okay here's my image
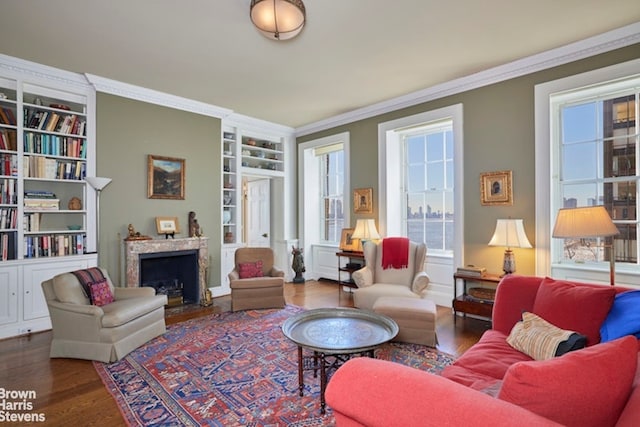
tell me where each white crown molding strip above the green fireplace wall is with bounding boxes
[84,74,232,119]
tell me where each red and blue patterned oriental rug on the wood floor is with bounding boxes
[94,306,454,427]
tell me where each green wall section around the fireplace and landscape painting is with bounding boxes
[96,93,221,286]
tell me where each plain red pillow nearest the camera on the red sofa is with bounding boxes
[498,336,638,427]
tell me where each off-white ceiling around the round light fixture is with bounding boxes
[0,0,640,127]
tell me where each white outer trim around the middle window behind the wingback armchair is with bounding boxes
[378,104,464,265]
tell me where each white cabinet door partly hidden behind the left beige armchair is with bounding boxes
[23,259,90,320]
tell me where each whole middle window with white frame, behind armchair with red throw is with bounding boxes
[378,104,464,264]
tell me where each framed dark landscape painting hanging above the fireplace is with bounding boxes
[147,154,185,200]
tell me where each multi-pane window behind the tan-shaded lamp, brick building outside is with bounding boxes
[551,83,640,264]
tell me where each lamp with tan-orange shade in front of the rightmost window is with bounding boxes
[552,205,620,286]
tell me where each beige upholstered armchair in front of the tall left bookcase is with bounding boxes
[42,269,167,363]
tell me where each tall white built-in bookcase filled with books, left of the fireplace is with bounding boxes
[0,55,97,339]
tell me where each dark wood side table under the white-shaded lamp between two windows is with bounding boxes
[453,273,502,322]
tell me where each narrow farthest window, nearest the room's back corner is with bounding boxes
[315,144,344,242]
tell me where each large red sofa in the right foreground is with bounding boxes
[326,275,640,427]
